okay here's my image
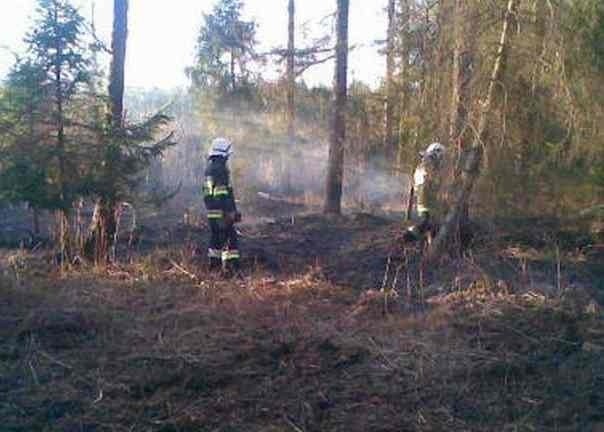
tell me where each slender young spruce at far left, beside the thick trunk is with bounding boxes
[19,0,88,261]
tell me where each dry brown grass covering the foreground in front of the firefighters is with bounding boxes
[0,243,604,432]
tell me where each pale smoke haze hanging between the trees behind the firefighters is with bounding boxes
[129,92,409,221]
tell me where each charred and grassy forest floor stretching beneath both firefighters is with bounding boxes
[0,208,604,432]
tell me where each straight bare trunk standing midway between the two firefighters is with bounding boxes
[324,0,349,214]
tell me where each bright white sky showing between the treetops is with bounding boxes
[0,0,386,88]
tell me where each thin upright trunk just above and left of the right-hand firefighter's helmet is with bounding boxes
[384,0,396,154]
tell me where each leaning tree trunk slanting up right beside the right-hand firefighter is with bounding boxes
[427,0,519,261]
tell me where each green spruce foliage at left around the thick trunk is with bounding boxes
[0,0,174,221]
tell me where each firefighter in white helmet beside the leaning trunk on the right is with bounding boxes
[404,143,446,241]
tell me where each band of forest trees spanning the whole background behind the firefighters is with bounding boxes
[0,0,604,256]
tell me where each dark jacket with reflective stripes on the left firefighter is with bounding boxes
[203,156,237,219]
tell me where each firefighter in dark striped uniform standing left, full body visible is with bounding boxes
[203,138,241,272]
